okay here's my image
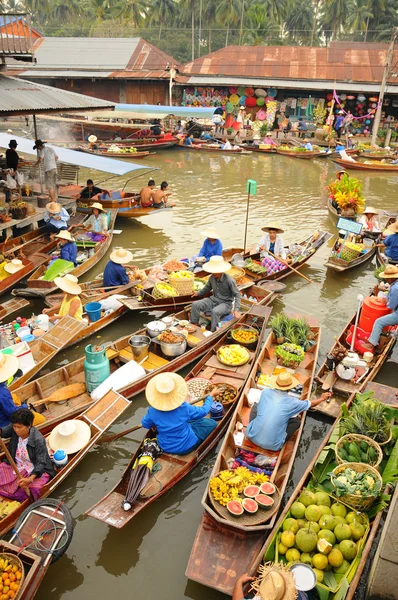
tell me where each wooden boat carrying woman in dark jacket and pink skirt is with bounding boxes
[0,390,131,535]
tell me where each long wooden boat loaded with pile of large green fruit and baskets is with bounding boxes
[246,386,398,600]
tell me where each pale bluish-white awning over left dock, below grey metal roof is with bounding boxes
[0,133,153,175]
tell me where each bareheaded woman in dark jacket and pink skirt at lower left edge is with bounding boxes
[0,408,55,502]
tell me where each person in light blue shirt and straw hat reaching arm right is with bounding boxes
[246,371,331,451]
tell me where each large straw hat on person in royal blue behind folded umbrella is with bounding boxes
[145,373,188,412]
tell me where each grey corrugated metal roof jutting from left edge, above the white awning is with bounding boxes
[0,75,115,116]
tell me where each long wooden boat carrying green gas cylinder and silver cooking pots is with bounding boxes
[13,285,276,432]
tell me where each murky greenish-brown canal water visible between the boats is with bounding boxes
[31,149,398,600]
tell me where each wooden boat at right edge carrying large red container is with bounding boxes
[314,315,395,417]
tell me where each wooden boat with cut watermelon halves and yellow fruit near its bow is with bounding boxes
[185,327,320,594]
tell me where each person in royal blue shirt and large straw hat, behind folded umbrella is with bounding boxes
[141,373,219,455]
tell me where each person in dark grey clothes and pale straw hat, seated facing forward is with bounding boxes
[191,256,241,331]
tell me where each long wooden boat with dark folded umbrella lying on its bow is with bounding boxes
[86,306,271,529]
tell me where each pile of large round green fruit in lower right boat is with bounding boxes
[276,489,368,585]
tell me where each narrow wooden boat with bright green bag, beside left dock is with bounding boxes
[13,209,117,298]
